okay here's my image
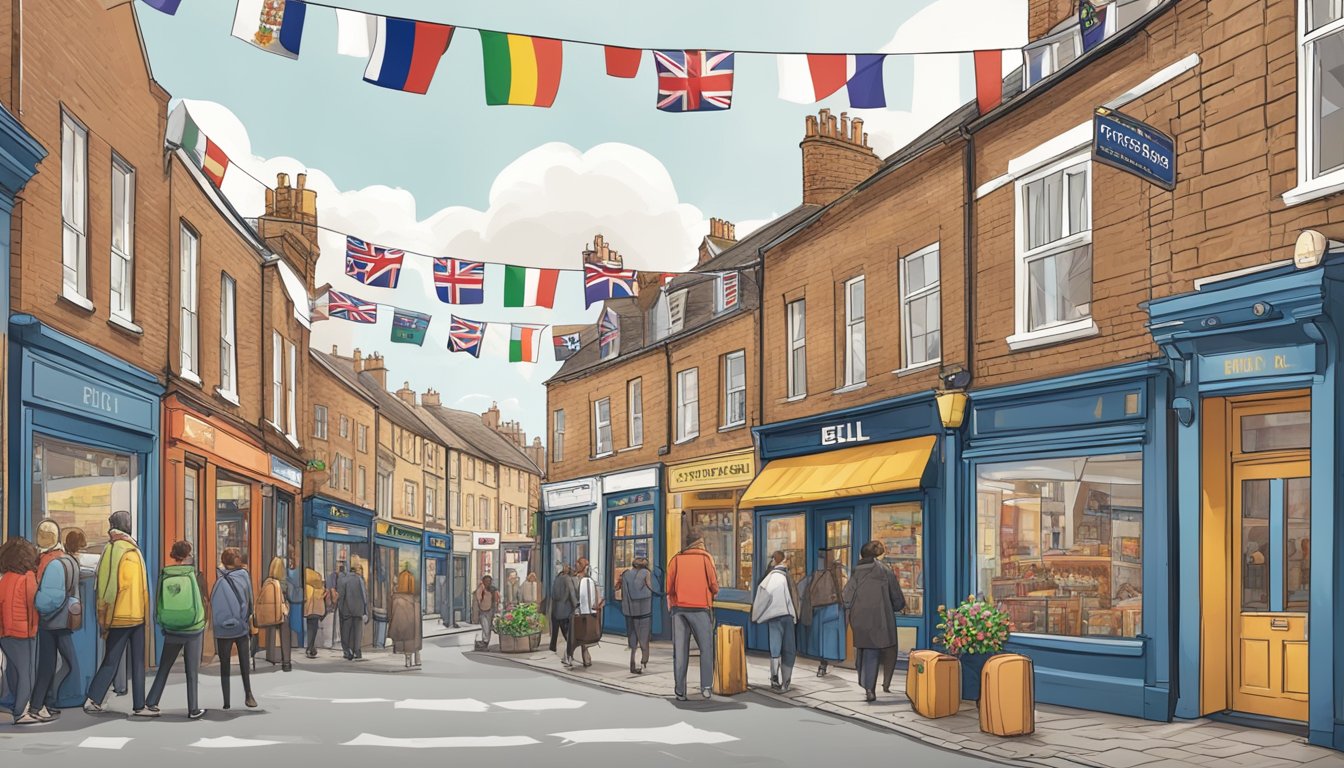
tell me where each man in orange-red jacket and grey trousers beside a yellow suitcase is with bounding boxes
[667,531,719,701]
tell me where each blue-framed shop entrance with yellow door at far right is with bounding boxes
[1148,253,1344,749]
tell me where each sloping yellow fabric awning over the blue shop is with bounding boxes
[739,434,937,507]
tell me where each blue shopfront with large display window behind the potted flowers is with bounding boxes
[958,363,1172,720]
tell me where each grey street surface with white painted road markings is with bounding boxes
[0,639,995,768]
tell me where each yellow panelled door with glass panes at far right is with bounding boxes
[1228,460,1312,721]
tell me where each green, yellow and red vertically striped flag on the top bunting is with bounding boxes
[481,30,562,106]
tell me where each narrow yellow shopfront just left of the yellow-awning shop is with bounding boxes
[659,449,755,625]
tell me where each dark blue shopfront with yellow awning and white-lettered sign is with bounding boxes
[736,391,966,659]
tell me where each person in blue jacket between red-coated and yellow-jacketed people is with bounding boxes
[30,519,83,722]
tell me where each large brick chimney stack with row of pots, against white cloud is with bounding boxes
[800,109,882,206]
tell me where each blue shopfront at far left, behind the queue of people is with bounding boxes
[8,315,163,706]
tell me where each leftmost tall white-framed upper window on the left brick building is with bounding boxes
[60,110,93,303]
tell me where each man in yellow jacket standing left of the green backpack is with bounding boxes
[83,510,149,717]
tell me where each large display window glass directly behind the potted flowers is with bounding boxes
[976,453,1144,638]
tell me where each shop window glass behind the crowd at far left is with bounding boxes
[30,437,140,561]
